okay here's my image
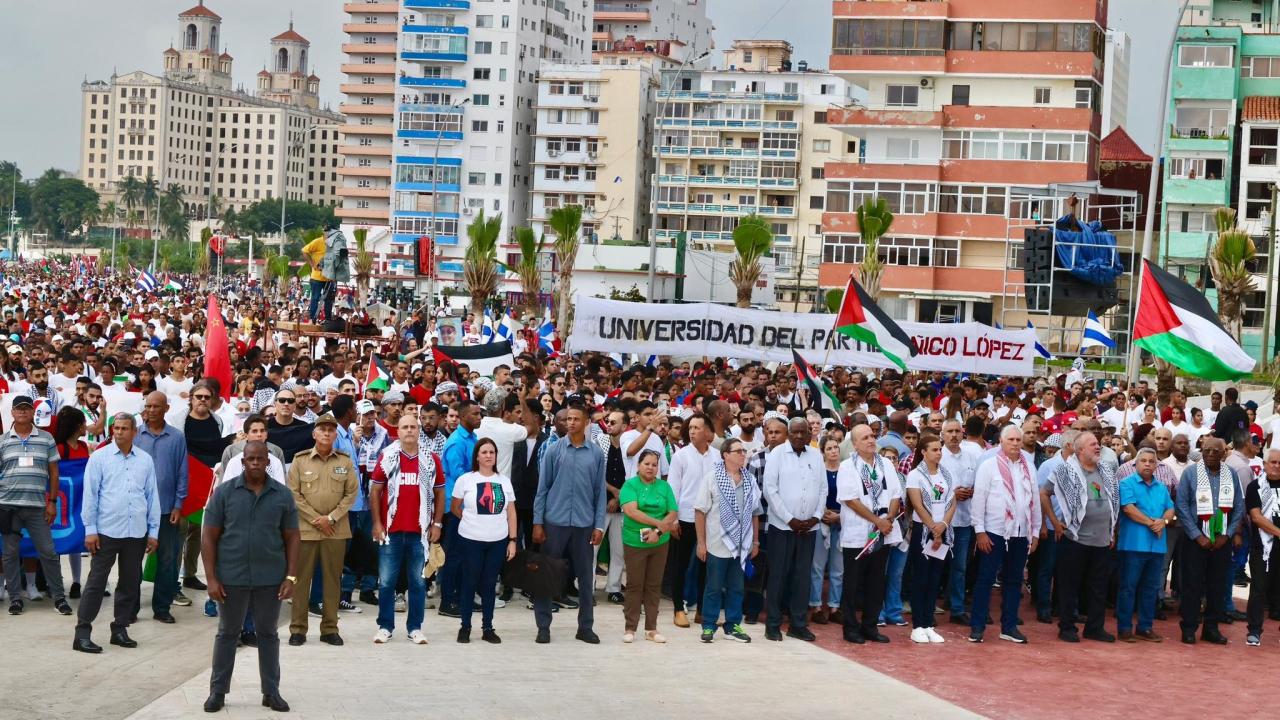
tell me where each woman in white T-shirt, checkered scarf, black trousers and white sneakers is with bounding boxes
[906,436,956,643]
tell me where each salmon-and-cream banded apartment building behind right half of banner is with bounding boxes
[820,0,1106,323]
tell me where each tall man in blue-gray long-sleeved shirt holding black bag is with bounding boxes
[534,404,608,644]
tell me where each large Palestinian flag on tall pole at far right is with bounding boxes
[1133,260,1254,380]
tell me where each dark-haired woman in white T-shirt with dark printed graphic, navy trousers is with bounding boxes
[452,438,516,643]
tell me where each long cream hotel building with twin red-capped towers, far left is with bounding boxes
[79,0,342,218]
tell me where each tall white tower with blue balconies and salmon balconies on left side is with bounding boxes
[342,0,591,281]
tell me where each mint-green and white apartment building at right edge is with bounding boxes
[1161,0,1280,356]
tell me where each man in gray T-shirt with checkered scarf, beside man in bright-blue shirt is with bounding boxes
[1041,433,1120,643]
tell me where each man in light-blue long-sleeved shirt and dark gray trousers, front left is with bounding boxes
[72,413,160,653]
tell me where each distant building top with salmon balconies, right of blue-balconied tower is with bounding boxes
[591,0,716,61]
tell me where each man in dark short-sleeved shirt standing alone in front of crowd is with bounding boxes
[200,441,299,712]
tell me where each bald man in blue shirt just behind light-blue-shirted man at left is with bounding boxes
[133,391,191,623]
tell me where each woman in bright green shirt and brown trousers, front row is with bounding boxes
[618,450,678,643]
